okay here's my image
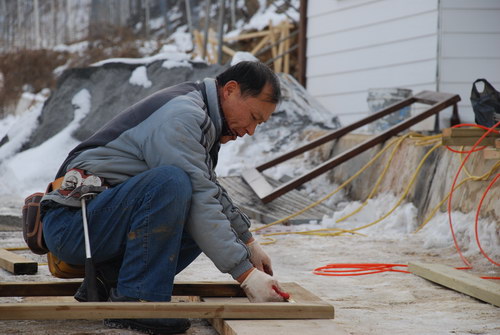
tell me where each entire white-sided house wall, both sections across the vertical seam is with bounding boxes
[307,0,500,129]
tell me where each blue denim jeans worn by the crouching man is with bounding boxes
[43,166,201,301]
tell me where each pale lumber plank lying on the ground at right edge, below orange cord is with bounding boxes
[408,262,500,307]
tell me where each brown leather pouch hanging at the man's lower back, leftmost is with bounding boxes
[23,192,49,255]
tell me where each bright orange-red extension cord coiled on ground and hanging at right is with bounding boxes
[313,122,500,280]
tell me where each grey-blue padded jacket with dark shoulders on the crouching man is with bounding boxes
[47,79,252,278]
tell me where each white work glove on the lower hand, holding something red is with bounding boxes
[240,268,285,302]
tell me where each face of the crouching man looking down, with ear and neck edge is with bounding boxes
[220,81,276,143]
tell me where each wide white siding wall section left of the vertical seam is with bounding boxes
[307,0,438,124]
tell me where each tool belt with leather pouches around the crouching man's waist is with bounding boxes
[22,169,107,278]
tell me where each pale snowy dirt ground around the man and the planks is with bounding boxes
[0,218,500,335]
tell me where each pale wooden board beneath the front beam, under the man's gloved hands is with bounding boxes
[204,283,342,335]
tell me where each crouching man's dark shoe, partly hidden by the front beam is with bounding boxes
[104,288,191,335]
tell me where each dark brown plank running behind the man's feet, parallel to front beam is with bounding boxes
[0,280,245,297]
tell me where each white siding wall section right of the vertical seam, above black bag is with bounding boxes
[438,0,500,122]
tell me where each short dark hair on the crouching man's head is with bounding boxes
[217,61,281,104]
